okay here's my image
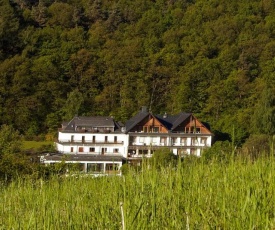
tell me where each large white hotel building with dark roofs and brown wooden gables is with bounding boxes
[50,112,212,172]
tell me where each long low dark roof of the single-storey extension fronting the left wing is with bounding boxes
[44,154,124,162]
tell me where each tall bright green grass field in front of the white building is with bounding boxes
[0,158,275,230]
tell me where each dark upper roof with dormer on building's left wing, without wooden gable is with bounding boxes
[64,116,118,131]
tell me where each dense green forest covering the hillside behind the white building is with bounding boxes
[0,0,275,144]
